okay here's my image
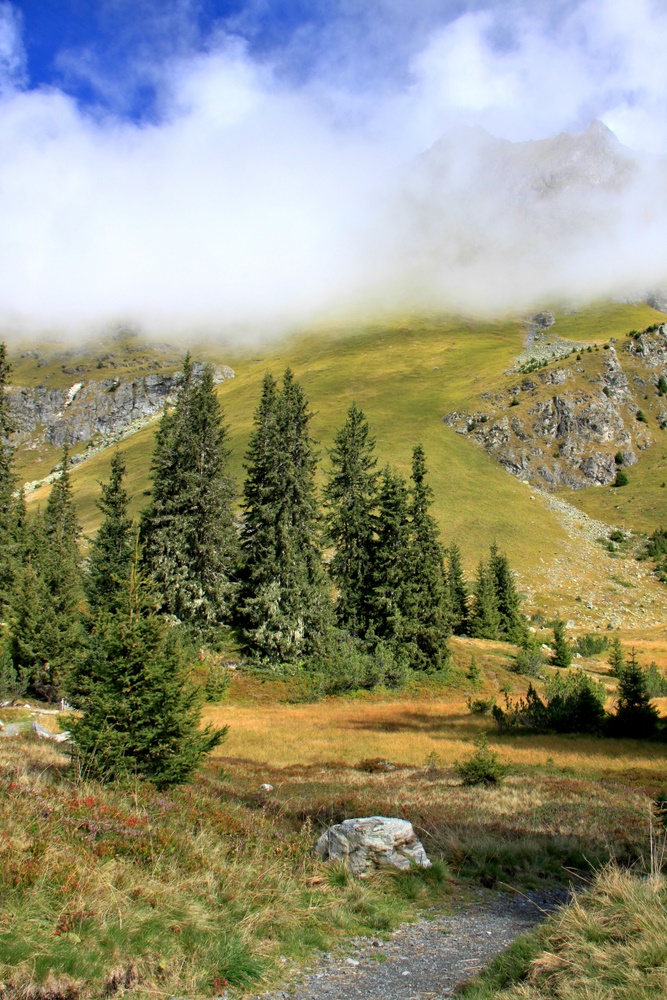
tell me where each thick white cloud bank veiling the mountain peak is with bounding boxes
[0,0,667,339]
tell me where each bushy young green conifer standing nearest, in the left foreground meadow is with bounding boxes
[70,557,226,787]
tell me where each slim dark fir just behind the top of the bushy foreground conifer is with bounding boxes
[86,451,135,611]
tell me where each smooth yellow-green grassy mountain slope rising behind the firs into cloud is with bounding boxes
[16,304,667,613]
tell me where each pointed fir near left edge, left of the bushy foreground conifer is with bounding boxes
[10,447,84,700]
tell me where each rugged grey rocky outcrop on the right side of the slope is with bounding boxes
[444,324,667,489]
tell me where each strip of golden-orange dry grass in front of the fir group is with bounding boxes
[205,694,667,780]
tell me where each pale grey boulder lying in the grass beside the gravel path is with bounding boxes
[315,816,431,876]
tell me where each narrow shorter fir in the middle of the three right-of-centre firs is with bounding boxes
[371,465,412,653]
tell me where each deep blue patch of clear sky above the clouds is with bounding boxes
[14,0,496,119]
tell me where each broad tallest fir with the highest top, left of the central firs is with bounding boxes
[140,354,237,636]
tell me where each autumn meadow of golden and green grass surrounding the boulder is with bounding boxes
[0,634,667,1000]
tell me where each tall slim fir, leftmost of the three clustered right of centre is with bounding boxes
[324,403,378,637]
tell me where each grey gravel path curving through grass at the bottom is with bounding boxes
[253,890,567,1000]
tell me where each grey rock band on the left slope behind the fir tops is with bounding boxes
[9,362,234,447]
